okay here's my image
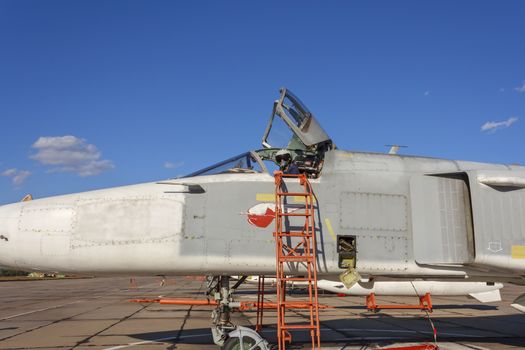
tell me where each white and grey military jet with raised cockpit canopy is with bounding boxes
[0,88,525,348]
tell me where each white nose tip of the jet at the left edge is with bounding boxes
[0,203,20,267]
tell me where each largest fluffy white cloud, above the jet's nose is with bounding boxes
[31,135,115,176]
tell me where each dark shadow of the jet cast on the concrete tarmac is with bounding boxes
[129,314,525,346]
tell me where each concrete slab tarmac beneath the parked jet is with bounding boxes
[0,277,525,350]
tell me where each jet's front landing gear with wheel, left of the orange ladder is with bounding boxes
[206,276,270,350]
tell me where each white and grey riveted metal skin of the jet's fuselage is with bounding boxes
[0,150,525,281]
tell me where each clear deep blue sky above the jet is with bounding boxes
[0,0,525,204]
